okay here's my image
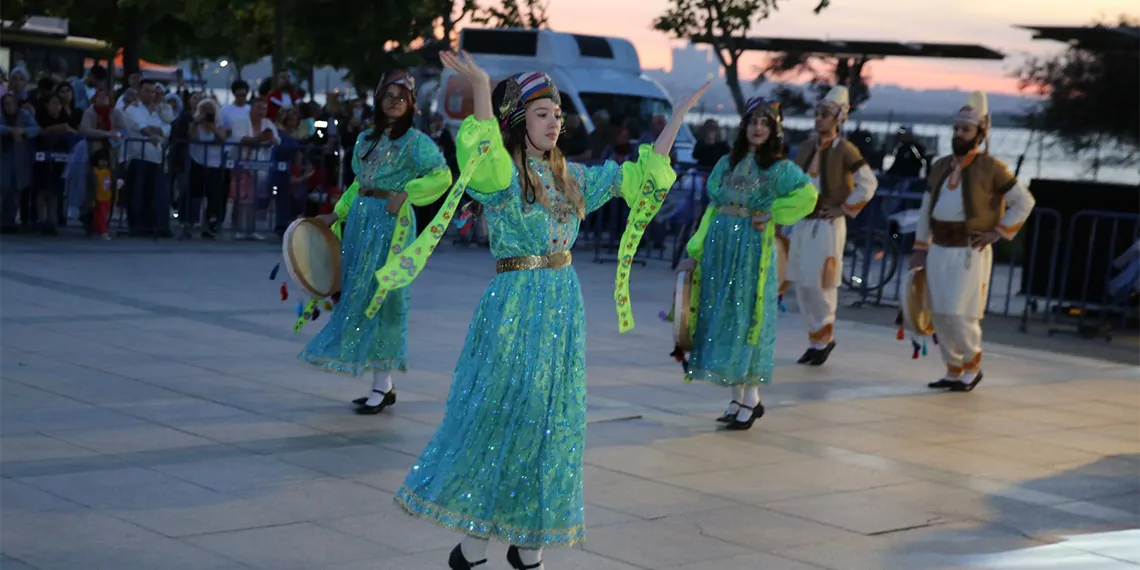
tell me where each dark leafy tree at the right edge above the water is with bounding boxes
[1015,16,1140,168]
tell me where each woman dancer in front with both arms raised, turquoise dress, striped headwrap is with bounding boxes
[396,54,703,570]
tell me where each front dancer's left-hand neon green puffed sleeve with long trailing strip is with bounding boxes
[355,117,499,318]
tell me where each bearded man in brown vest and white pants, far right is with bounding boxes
[911,91,1035,392]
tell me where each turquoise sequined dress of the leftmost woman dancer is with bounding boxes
[300,129,451,376]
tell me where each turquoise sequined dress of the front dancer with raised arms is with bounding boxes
[396,117,676,548]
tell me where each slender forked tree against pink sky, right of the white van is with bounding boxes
[653,0,830,114]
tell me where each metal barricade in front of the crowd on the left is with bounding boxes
[0,133,342,238]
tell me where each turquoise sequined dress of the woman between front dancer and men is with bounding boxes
[689,154,816,385]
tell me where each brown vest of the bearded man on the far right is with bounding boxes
[927,153,1017,235]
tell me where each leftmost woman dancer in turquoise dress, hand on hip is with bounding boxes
[301,71,451,414]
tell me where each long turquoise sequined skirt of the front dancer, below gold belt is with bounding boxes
[396,262,586,548]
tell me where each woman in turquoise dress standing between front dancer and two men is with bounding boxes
[682,98,816,430]
